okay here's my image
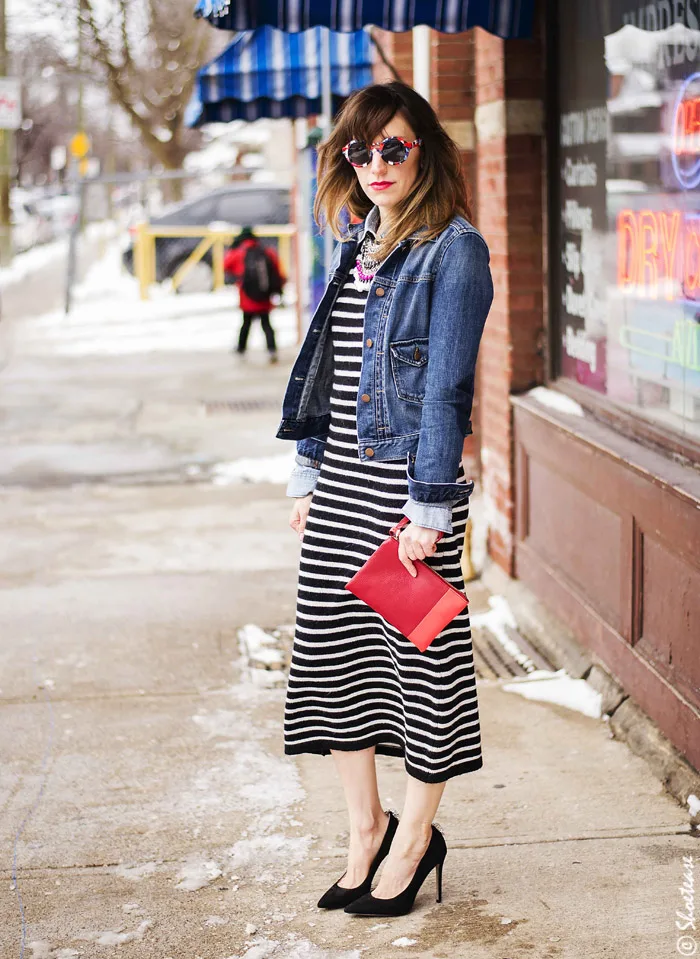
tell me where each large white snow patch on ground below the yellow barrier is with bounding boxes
[15,241,297,356]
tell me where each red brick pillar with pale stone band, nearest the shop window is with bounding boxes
[474,30,544,575]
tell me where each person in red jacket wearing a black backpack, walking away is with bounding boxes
[224,226,287,363]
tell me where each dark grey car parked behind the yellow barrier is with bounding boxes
[122,183,291,293]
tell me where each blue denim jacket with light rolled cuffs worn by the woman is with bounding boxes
[276,206,493,533]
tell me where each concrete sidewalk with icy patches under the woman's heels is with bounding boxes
[0,326,700,959]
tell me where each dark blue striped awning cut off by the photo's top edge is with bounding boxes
[195,0,534,38]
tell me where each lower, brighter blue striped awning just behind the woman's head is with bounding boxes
[185,26,372,126]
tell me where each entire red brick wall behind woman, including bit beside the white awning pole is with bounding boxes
[377,29,544,575]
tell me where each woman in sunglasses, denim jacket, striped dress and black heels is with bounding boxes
[277,82,493,915]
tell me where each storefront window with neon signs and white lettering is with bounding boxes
[554,0,700,438]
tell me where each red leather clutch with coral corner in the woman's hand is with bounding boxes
[345,516,469,653]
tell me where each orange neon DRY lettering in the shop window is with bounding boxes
[617,210,700,301]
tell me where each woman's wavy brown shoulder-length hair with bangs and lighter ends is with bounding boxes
[314,80,471,259]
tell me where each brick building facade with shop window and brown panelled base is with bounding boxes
[378,0,700,769]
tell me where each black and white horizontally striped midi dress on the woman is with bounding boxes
[284,266,483,782]
